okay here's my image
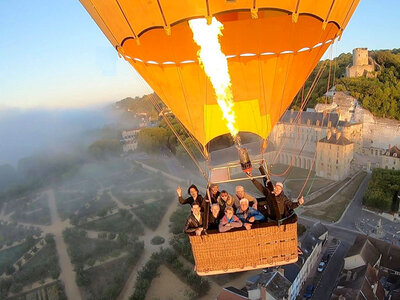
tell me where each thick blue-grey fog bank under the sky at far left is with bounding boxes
[0,108,122,166]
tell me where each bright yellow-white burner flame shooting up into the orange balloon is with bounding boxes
[189,17,238,139]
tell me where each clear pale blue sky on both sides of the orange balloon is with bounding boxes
[0,0,400,110]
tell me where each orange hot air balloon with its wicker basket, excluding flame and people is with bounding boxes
[80,0,359,275]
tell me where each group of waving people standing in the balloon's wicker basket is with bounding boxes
[176,178,304,235]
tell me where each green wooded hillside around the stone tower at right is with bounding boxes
[292,49,400,120]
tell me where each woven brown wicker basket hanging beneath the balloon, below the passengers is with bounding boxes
[189,217,297,276]
